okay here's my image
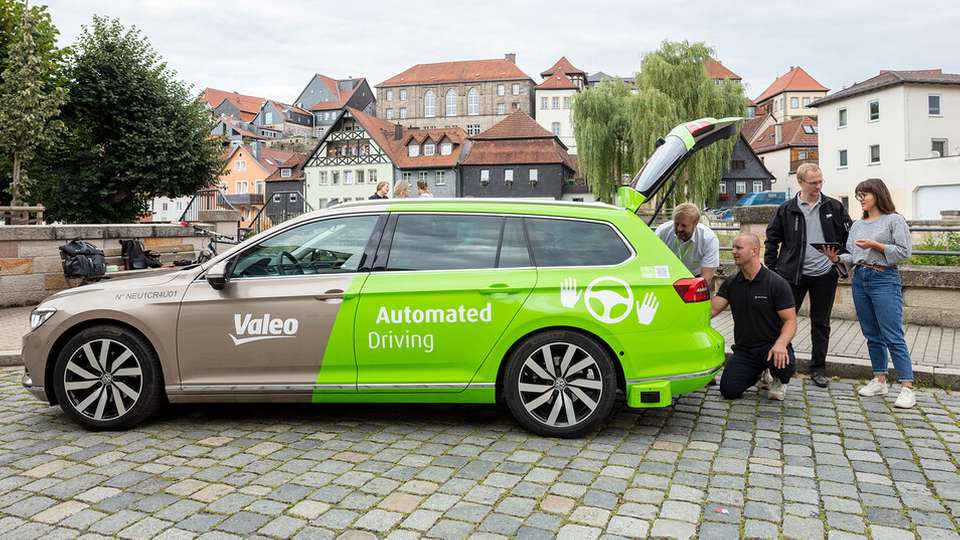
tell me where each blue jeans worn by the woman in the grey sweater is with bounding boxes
[853,267,913,381]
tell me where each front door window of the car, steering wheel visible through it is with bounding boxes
[230,215,378,279]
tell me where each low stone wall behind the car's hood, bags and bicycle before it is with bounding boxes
[0,224,206,307]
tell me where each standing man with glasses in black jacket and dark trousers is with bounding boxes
[763,163,851,388]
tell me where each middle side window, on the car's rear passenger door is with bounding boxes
[386,214,503,270]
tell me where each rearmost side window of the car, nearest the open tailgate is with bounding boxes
[526,218,630,267]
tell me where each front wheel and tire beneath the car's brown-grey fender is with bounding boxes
[53,326,165,431]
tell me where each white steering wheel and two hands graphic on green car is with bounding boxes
[560,276,660,325]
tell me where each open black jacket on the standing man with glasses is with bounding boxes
[763,194,852,284]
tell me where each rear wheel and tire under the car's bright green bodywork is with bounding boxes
[502,330,617,438]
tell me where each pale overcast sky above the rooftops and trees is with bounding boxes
[43,0,960,102]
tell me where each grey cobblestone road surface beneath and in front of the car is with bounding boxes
[0,368,960,540]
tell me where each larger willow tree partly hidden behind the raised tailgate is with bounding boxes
[630,41,745,205]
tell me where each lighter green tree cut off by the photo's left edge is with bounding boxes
[0,0,66,205]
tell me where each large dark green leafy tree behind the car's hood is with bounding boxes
[31,17,223,223]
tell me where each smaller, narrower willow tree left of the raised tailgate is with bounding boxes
[573,80,636,202]
